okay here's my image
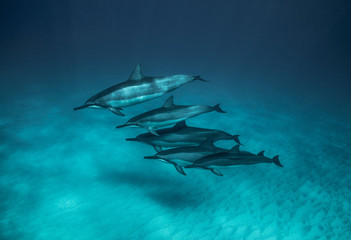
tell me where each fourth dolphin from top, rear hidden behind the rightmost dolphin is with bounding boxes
[144,137,227,175]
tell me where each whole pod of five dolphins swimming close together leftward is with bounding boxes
[74,64,283,176]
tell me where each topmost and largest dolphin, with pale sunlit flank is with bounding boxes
[74,64,206,116]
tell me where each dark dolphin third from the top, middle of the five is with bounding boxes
[126,121,242,152]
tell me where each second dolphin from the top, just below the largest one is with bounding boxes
[116,96,225,135]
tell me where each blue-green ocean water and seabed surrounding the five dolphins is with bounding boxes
[0,0,351,240]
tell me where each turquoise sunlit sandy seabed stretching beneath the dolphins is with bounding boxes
[0,88,351,240]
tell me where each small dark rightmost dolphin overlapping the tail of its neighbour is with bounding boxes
[185,145,283,176]
